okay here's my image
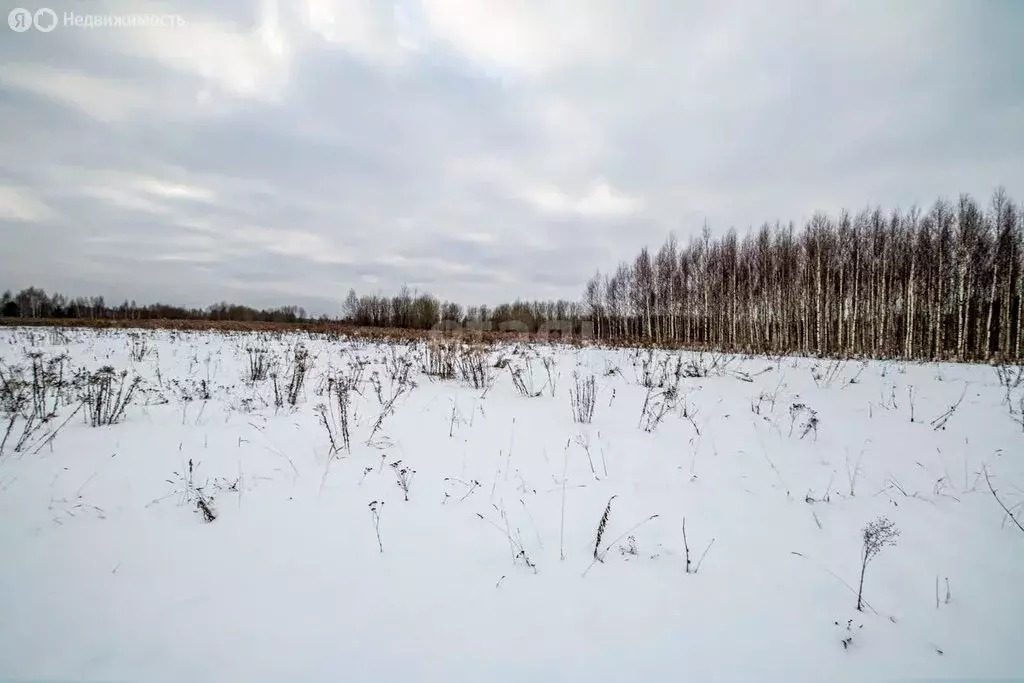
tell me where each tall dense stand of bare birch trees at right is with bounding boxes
[584,188,1024,360]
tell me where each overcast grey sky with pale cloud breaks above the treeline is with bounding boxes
[0,0,1024,313]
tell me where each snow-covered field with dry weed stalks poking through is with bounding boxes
[0,329,1024,682]
